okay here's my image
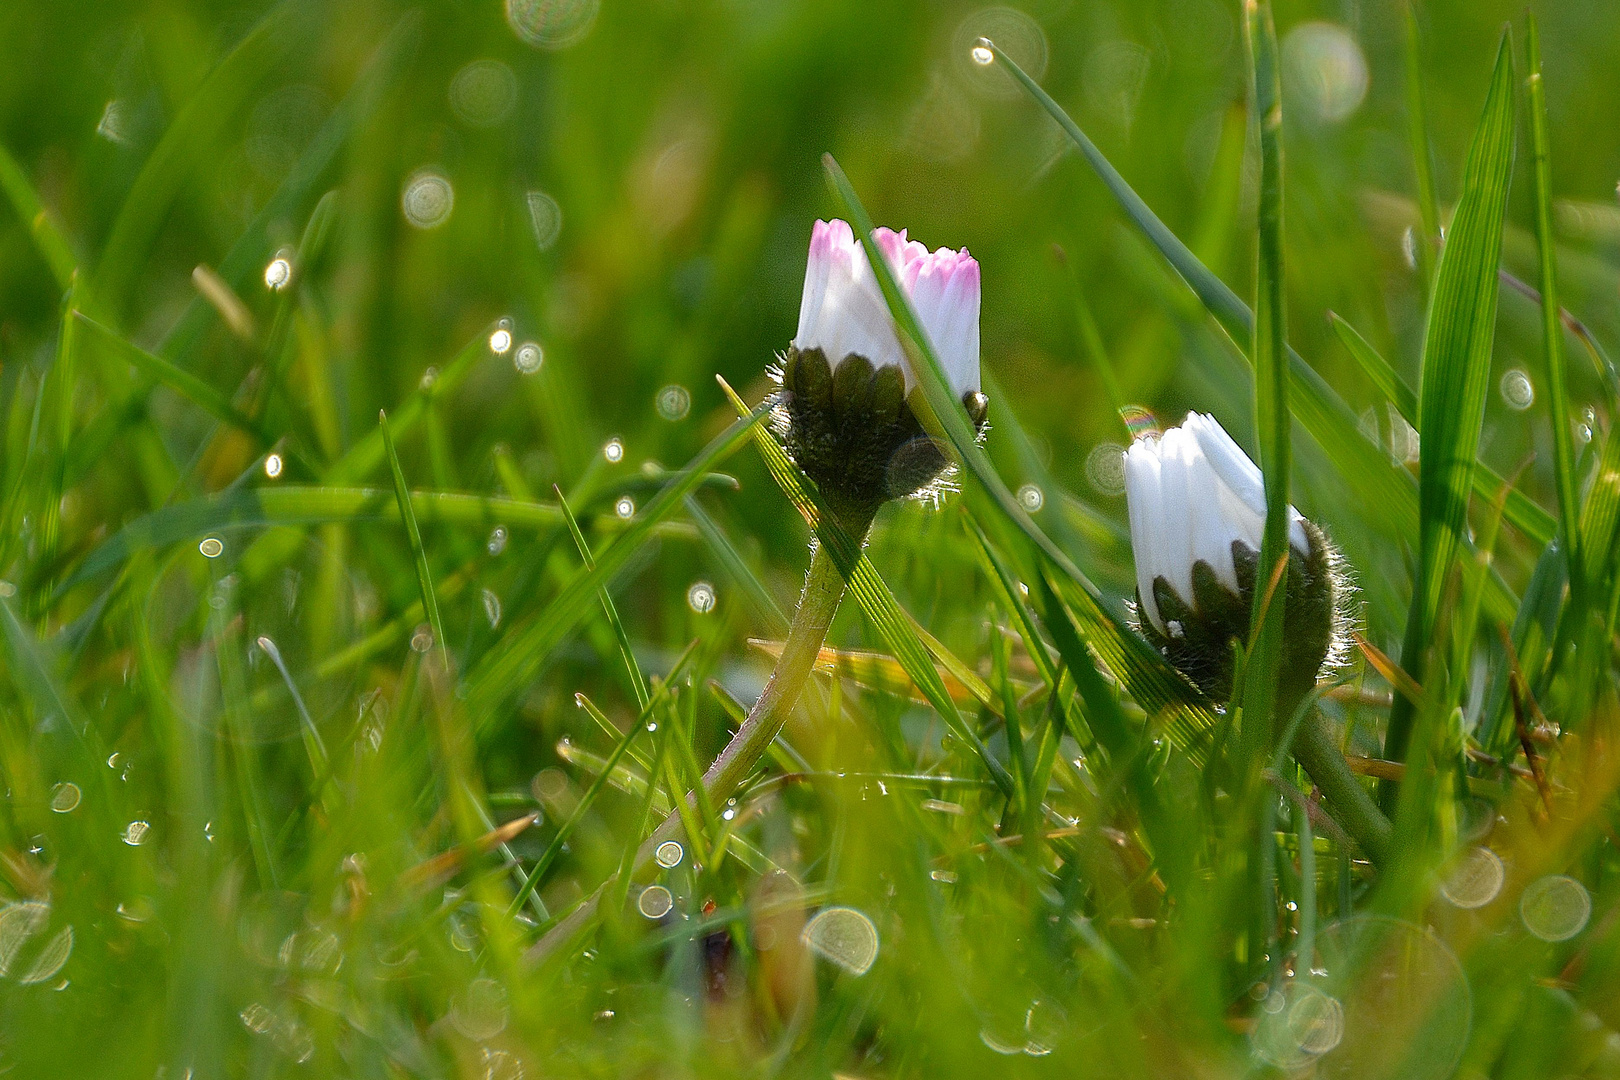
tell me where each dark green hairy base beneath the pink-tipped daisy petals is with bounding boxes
[778,348,990,517]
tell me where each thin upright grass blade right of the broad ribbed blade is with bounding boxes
[1524,11,1586,617]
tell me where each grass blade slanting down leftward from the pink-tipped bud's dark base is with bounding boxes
[467,408,770,730]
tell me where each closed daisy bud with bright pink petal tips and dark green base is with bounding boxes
[778,220,988,517]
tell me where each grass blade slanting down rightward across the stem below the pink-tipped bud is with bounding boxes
[721,381,1014,795]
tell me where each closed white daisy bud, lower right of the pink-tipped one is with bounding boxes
[1124,413,1346,703]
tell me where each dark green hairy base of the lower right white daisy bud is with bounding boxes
[1136,521,1340,703]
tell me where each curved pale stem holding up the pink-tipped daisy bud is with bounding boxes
[528,537,870,965]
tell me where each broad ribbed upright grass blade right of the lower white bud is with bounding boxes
[1383,31,1513,777]
